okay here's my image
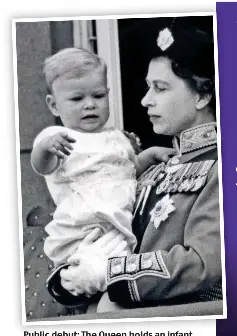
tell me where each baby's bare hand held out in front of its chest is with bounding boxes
[44,132,76,159]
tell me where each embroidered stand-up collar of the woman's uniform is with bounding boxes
[173,122,217,156]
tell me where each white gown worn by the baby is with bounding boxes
[34,126,136,266]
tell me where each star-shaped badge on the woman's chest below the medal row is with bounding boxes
[150,194,175,229]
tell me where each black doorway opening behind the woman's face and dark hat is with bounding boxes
[118,16,213,148]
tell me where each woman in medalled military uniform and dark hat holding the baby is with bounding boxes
[49,18,222,311]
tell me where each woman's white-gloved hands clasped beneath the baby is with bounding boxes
[60,229,127,297]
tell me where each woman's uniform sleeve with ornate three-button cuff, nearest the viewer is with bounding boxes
[107,163,222,303]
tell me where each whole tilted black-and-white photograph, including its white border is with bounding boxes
[13,13,226,324]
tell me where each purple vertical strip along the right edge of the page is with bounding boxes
[216,2,237,336]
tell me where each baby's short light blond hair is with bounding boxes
[43,48,107,93]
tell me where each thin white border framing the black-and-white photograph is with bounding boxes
[12,12,227,326]
